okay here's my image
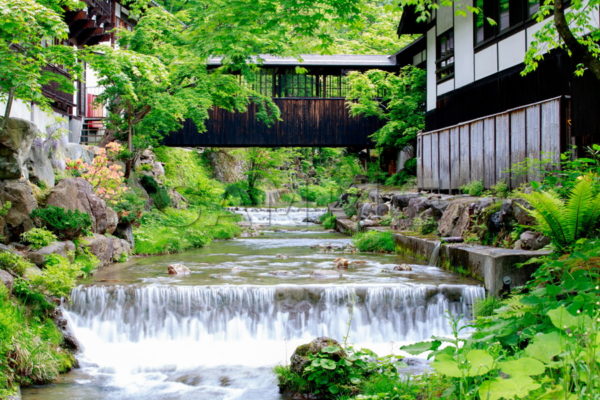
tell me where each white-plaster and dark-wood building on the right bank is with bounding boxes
[398,0,600,191]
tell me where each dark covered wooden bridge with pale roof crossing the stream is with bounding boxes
[164,55,396,148]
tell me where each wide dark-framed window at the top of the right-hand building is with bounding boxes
[474,0,540,45]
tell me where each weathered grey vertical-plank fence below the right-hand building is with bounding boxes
[417,97,568,191]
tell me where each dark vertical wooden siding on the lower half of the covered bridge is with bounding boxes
[164,98,382,148]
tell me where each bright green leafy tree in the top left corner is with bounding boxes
[0,0,81,131]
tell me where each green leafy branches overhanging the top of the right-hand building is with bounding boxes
[400,0,600,80]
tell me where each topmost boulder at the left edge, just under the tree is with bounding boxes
[0,118,39,179]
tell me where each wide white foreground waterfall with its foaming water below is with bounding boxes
[61,285,484,399]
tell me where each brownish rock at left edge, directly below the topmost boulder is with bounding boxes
[0,180,38,240]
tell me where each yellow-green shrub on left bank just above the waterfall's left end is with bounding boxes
[31,254,82,297]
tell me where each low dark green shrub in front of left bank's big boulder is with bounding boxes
[31,206,92,240]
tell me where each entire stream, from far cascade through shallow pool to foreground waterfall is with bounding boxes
[23,209,484,400]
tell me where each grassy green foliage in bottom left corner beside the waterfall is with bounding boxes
[0,281,75,398]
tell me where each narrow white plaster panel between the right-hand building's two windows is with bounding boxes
[454,0,475,89]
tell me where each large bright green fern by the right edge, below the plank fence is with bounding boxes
[519,174,600,251]
